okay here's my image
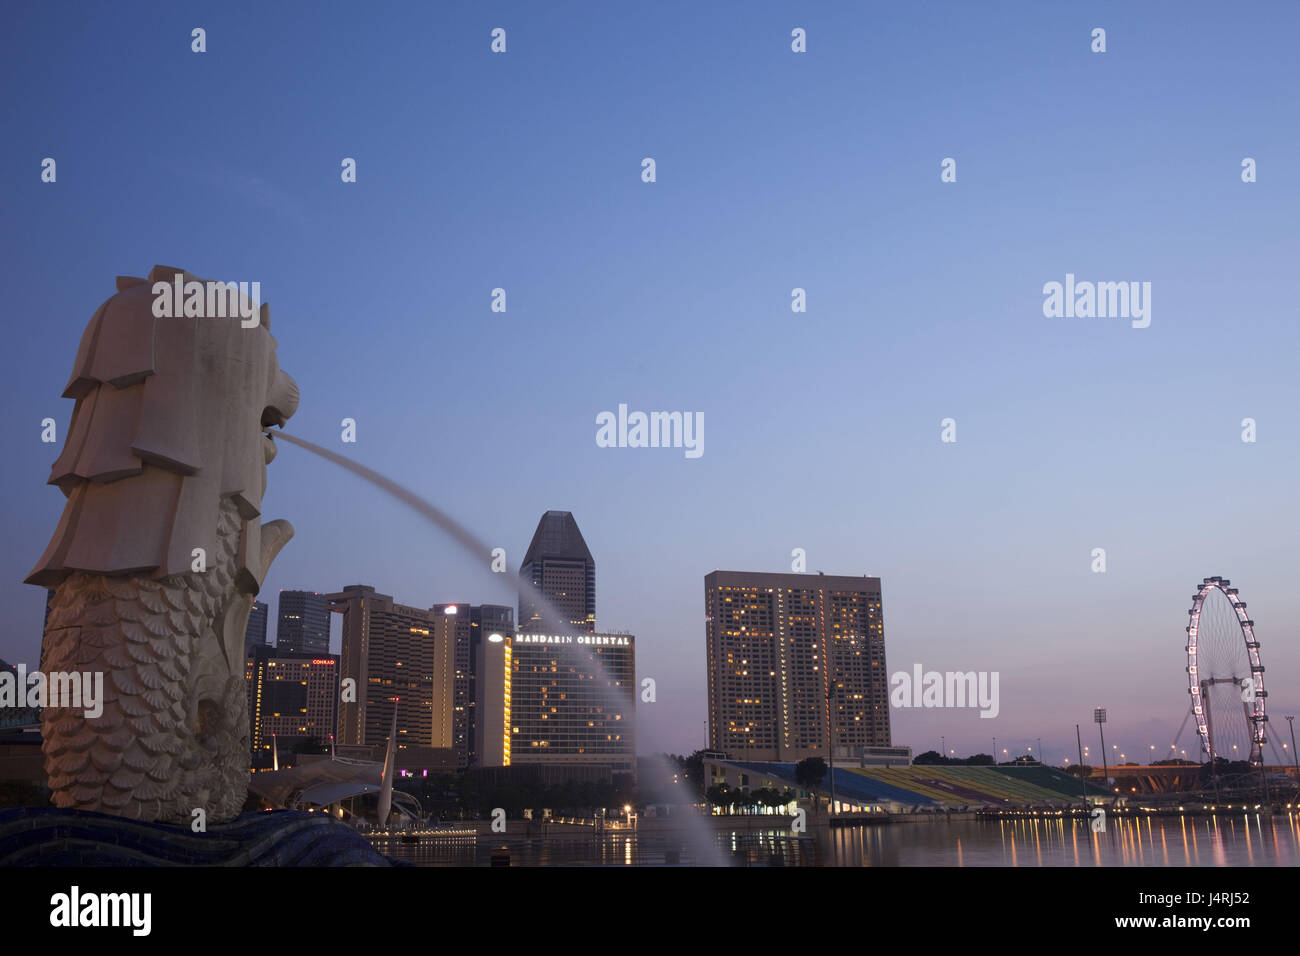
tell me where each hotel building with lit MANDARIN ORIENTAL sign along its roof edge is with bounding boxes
[510,633,637,774]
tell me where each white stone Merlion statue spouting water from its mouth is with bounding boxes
[27,265,298,823]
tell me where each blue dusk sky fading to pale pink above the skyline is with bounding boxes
[0,3,1300,761]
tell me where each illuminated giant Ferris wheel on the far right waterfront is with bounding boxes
[1186,576,1269,767]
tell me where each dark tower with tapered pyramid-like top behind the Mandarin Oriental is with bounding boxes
[519,511,595,633]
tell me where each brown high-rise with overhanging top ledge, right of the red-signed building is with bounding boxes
[326,584,444,750]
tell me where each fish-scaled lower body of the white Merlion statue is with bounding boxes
[42,501,250,823]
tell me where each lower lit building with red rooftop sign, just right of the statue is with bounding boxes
[244,645,338,770]
